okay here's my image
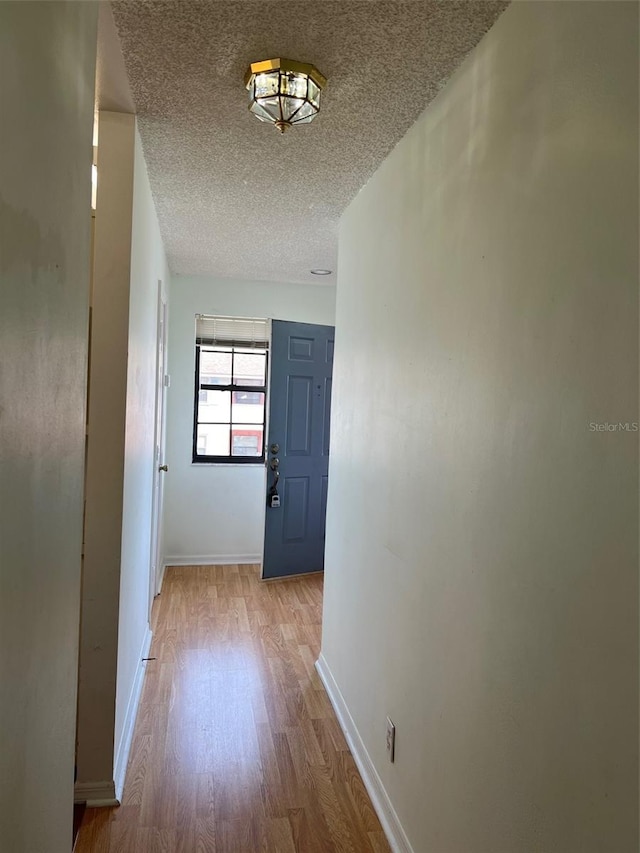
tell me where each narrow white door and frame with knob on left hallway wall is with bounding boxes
[149,279,169,618]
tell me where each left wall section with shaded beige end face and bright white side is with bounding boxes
[76,116,168,805]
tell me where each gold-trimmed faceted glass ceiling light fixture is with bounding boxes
[244,59,327,133]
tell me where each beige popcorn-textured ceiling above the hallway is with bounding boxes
[112,0,508,284]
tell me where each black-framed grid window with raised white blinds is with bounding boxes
[192,315,267,463]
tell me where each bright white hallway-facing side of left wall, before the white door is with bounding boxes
[115,126,169,795]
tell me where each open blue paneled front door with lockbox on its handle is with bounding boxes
[262,320,334,578]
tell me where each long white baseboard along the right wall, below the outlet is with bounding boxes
[316,654,413,853]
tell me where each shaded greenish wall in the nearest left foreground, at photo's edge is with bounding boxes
[0,3,97,853]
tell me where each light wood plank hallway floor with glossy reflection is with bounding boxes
[76,565,389,853]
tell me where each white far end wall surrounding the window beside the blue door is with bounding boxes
[163,276,335,565]
